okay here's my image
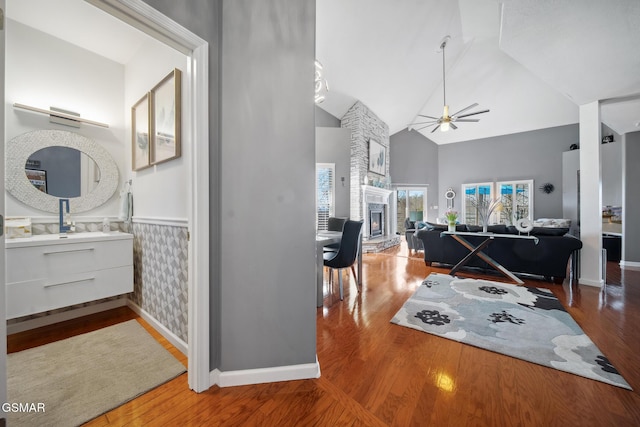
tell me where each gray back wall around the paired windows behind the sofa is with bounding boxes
[438,125,579,218]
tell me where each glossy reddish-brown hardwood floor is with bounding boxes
[9,246,640,426]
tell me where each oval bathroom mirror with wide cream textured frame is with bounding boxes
[5,130,119,213]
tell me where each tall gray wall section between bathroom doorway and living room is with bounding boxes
[145,0,316,371]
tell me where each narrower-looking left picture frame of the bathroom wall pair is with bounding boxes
[131,93,152,171]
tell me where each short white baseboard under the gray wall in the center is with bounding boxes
[209,357,320,387]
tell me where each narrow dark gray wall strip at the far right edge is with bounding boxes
[622,132,640,267]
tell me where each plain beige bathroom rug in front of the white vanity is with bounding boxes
[7,320,185,427]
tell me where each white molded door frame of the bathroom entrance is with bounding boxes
[85,0,211,392]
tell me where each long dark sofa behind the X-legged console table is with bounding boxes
[415,223,582,283]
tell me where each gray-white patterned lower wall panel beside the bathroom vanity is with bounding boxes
[130,222,188,342]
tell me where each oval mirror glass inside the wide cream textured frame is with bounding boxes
[25,146,100,199]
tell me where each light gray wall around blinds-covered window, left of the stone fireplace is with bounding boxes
[316,127,351,217]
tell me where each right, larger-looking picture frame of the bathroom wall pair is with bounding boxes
[149,68,182,165]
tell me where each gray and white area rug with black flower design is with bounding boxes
[391,273,631,390]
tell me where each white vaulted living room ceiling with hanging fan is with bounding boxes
[316,0,640,144]
